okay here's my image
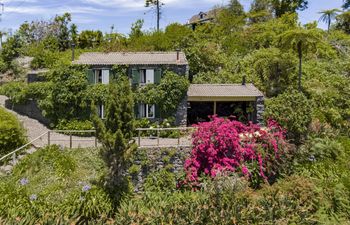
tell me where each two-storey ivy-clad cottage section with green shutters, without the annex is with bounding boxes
[73,51,189,120]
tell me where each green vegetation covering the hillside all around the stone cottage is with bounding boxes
[0,0,350,224]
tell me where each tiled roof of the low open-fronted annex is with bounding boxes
[187,84,264,97]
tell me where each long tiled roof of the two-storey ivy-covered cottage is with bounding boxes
[73,52,188,65]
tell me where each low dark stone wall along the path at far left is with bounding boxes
[5,99,50,126]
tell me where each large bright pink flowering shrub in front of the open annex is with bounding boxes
[184,117,287,187]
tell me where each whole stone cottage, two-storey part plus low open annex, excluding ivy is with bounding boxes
[73,51,264,126]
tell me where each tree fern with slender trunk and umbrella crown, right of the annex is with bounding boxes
[280,28,322,91]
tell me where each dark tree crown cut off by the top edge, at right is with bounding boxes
[270,0,308,17]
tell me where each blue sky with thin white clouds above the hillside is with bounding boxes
[0,0,343,34]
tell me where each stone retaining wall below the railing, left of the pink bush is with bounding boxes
[128,147,191,192]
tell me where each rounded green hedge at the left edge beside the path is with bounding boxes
[0,107,26,156]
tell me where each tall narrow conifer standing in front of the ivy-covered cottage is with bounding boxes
[93,76,134,200]
